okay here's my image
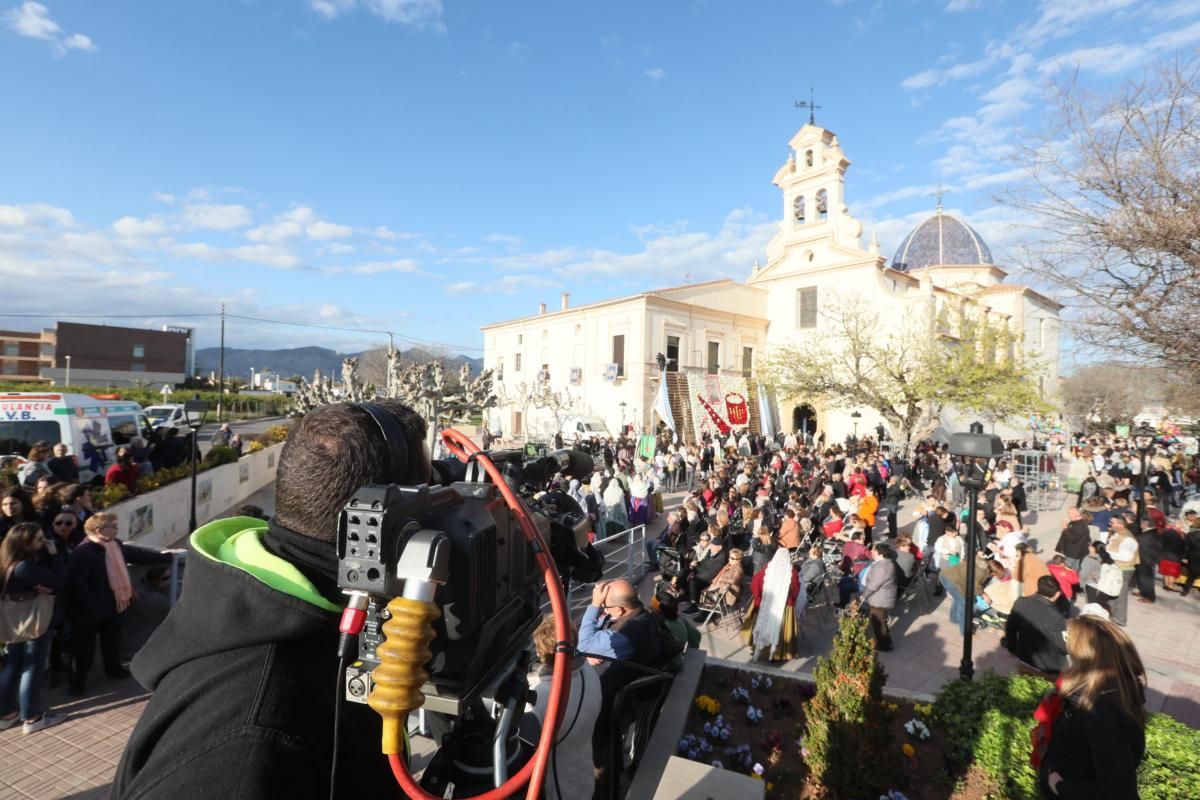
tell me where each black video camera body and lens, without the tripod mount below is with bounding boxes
[337,451,604,717]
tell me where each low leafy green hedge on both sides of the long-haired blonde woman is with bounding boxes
[934,673,1200,800]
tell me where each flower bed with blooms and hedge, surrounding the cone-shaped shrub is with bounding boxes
[677,666,1200,800]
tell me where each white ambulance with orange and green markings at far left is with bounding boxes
[0,392,150,482]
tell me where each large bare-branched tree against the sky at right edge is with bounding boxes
[1004,54,1200,375]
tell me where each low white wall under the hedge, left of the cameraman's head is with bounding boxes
[106,444,283,548]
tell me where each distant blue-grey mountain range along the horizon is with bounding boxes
[196,347,484,383]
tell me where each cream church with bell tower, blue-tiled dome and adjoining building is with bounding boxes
[482,124,1062,441]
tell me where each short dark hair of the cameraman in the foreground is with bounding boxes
[275,399,430,542]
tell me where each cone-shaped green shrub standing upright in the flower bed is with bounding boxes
[804,603,900,798]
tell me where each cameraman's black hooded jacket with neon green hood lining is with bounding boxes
[112,517,402,800]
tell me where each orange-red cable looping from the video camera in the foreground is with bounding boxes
[388,428,571,800]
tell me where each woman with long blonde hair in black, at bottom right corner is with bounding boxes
[1039,614,1146,800]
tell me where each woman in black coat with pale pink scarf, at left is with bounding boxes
[67,511,170,697]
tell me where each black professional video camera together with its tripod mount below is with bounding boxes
[337,450,604,788]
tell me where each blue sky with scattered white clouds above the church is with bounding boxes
[0,0,1200,356]
